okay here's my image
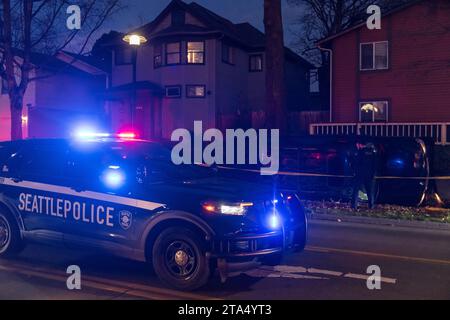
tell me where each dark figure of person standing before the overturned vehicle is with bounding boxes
[352,142,377,209]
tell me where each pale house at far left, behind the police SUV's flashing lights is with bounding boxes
[0,50,108,141]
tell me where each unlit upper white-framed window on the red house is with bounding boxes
[360,41,389,71]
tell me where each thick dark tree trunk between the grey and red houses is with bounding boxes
[264,0,287,134]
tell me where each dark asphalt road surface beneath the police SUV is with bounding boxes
[0,221,450,300]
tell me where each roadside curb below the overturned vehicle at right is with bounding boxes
[309,213,450,231]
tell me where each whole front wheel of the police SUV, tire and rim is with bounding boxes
[153,227,210,290]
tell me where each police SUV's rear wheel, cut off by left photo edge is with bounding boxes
[0,212,24,257]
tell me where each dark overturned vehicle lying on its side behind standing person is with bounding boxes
[223,136,431,206]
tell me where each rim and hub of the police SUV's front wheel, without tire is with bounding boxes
[166,241,197,278]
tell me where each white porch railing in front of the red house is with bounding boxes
[309,122,450,145]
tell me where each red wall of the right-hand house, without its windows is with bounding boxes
[332,0,450,122]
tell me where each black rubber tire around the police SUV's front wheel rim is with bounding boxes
[152,227,210,291]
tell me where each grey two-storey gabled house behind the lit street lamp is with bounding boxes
[100,0,314,138]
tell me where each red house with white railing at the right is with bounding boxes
[311,0,450,143]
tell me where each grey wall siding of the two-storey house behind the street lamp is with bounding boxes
[107,2,309,139]
